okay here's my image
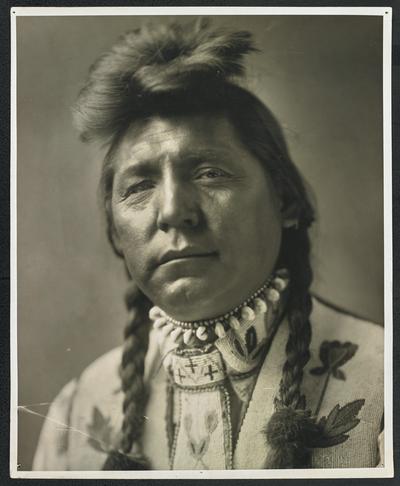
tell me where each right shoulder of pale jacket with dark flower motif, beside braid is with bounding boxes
[303,299,384,467]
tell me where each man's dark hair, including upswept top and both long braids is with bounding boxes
[74,19,314,469]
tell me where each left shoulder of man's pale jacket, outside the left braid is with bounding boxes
[33,347,123,471]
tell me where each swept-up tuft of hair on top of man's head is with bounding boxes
[74,19,254,141]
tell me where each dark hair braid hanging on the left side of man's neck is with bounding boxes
[103,286,151,470]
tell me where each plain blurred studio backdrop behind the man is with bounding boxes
[17,16,383,470]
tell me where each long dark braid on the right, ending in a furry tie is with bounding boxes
[265,223,313,469]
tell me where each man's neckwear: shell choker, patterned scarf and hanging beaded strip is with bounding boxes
[150,270,288,469]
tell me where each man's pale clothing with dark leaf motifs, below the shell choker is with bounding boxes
[33,299,384,471]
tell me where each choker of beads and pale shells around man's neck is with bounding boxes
[149,268,289,346]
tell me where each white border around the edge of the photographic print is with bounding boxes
[10,7,394,479]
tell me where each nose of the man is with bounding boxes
[157,177,201,232]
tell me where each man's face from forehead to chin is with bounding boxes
[111,115,282,321]
